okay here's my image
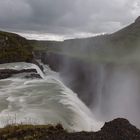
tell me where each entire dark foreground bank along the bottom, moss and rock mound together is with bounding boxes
[0,118,140,140]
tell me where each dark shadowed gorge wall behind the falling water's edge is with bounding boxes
[41,52,98,105]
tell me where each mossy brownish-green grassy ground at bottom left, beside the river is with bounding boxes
[0,124,67,140]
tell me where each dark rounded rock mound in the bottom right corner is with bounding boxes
[95,118,140,140]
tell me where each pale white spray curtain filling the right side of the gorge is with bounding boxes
[91,64,140,128]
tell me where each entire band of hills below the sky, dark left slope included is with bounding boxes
[0,17,140,63]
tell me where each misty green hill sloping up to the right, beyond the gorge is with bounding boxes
[33,17,140,62]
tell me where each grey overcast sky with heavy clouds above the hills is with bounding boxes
[0,0,140,40]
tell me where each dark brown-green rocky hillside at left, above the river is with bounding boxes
[0,31,33,63]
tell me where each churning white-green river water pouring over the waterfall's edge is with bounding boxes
[0,63,103,131]
